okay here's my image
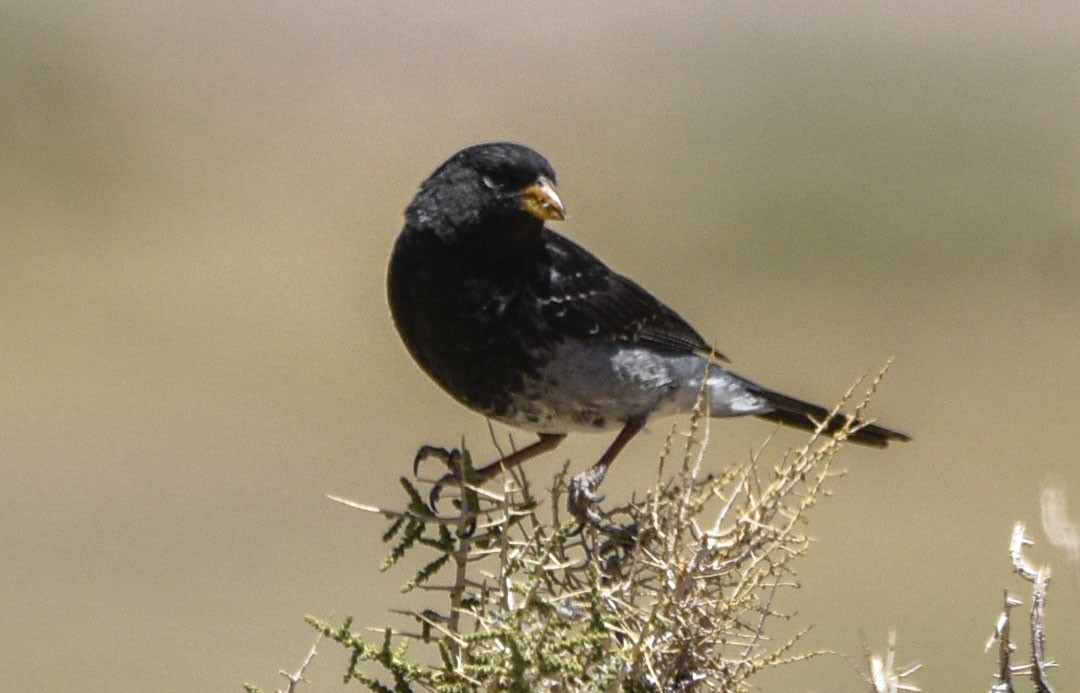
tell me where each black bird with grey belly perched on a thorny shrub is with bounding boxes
[387,141,910,521]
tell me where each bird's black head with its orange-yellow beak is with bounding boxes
[405,142,565,232]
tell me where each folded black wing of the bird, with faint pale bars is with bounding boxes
[531,229,723,358]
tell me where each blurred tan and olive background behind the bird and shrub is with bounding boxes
[0,1,1080,691]
